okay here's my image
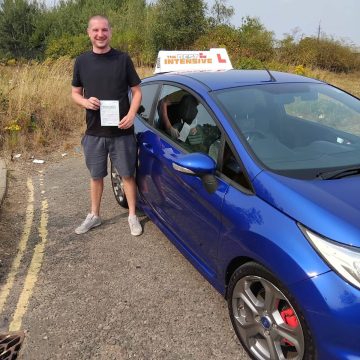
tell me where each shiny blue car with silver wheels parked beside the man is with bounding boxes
[112,61,360,360]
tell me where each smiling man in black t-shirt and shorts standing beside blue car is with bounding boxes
[71,15,142,236]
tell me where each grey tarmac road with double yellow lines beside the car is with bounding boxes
[0,155,248,360]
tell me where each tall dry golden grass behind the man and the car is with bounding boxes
[0,58,360,154]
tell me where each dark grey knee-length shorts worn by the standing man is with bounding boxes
[81,134,137,179]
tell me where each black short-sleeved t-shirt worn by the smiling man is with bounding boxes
[72,49,141,137]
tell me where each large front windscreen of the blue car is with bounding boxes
[215,83,360,178]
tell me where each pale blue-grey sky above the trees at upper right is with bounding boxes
[211,0,360,48]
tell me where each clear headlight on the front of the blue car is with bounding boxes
[299,224,360,289]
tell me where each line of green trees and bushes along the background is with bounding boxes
[0,0,360,72]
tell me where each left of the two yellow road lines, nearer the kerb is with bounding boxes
[0,178,34,314]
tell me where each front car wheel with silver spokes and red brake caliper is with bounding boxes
[228,263,315,360]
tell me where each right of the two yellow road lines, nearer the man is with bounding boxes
[9,199,48,331]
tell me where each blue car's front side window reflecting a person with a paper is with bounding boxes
[154,85,220,161]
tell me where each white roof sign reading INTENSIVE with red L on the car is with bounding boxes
[154,48,233,74]
